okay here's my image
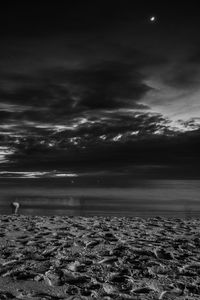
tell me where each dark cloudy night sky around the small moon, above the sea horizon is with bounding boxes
[0,1,200,178]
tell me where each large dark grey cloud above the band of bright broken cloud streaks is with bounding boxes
[0,62,150,121]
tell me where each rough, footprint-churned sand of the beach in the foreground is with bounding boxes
[0,216,200,300]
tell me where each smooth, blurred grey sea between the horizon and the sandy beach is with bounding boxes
[0,179,200,217]
